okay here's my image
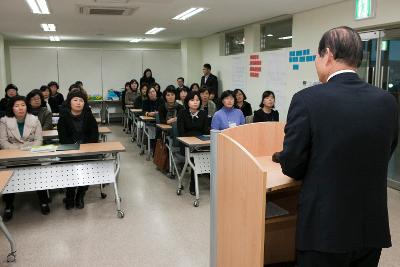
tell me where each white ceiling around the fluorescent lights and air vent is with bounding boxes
[0,0,343,43]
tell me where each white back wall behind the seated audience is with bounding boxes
[9,46,182,97]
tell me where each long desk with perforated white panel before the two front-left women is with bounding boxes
[0,142,125,218]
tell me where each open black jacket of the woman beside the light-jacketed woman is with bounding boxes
[57,107,99,144]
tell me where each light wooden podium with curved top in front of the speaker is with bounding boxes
[210,122,301,267]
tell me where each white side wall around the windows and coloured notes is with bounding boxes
[201,0,400,121]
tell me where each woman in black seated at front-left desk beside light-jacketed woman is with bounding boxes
[57,90,99,210]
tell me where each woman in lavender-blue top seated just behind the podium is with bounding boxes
[211,90,245,130]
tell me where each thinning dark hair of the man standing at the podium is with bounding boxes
[318,26,363,68]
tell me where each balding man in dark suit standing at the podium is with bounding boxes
[273,27,398,267]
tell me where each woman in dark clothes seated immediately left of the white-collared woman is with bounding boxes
[158,85,183,125]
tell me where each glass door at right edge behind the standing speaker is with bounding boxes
[357,29,400,190]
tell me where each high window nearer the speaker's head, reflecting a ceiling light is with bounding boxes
[260,18,293,51]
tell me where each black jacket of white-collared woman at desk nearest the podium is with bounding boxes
[178,109,210,136]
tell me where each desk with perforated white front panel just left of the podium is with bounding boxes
[176,136,211,207]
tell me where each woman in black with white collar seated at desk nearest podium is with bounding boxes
[178,91,210,195]
